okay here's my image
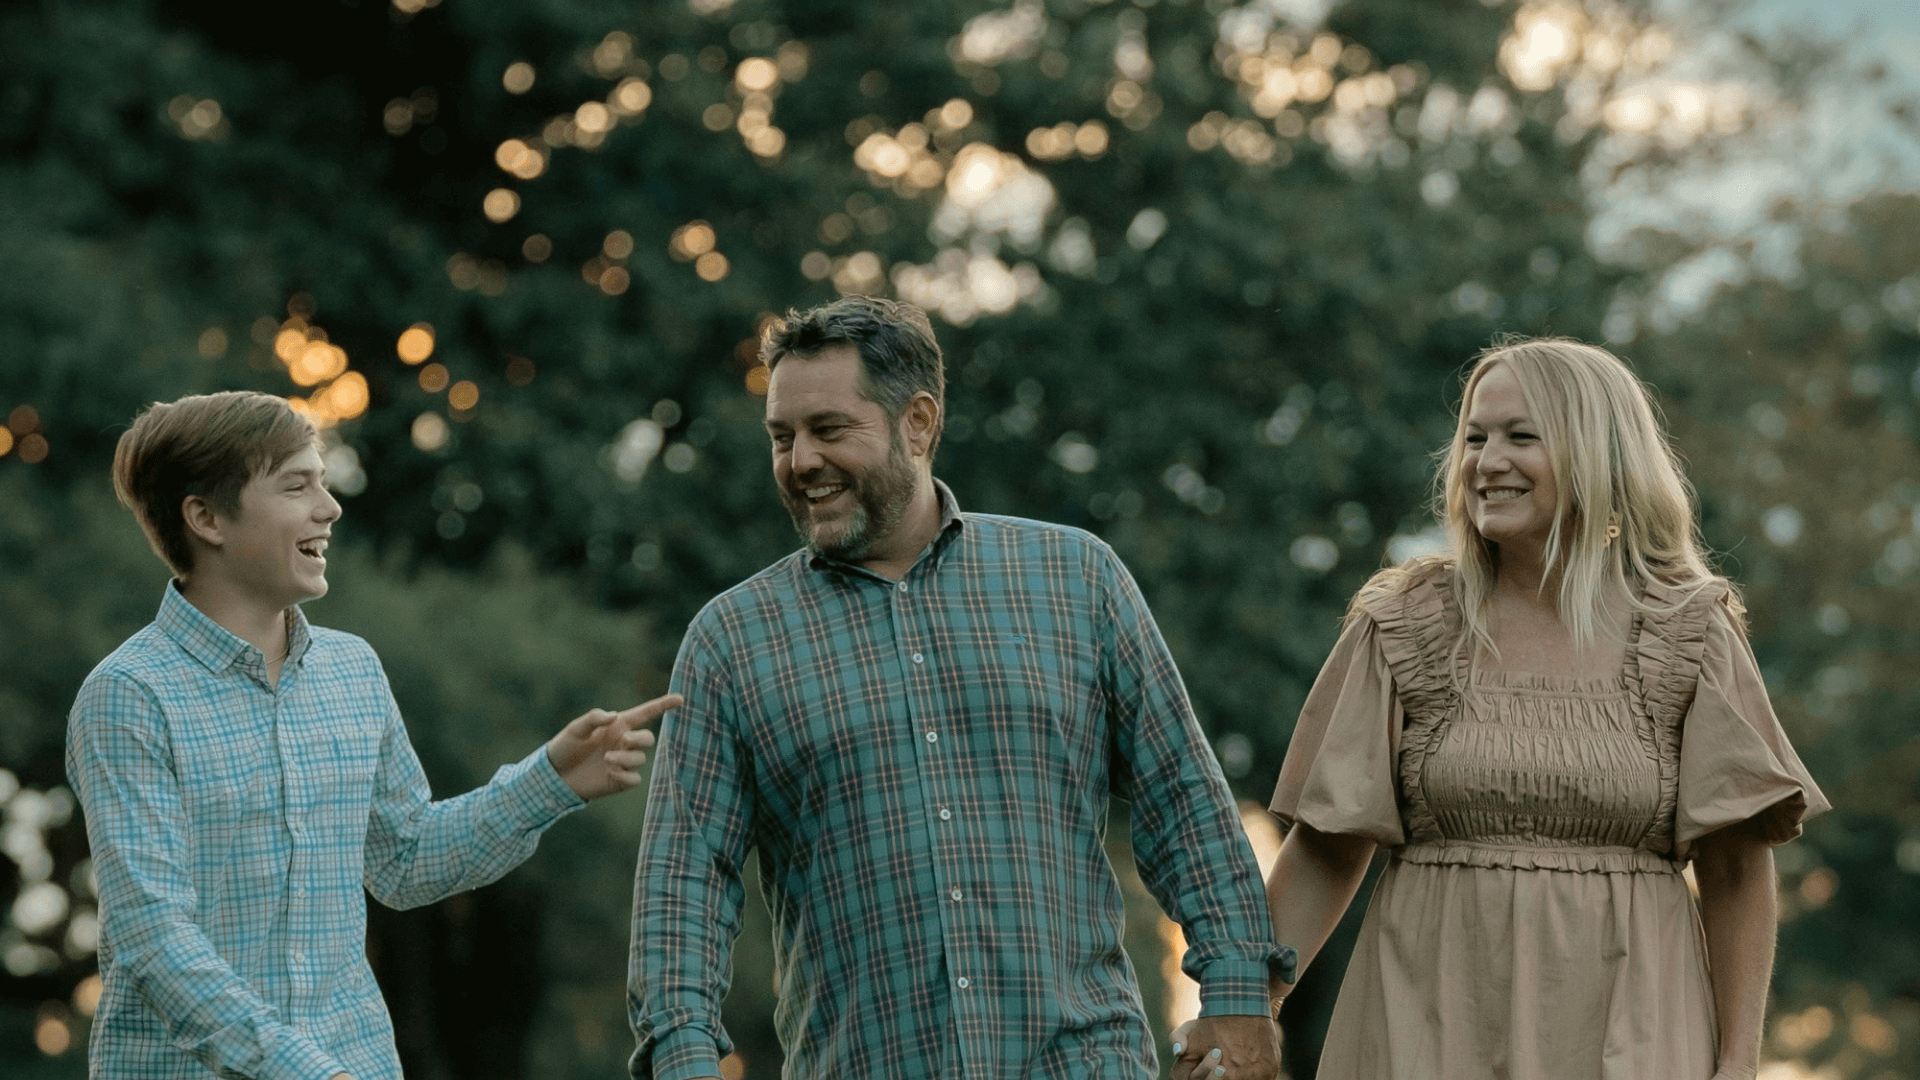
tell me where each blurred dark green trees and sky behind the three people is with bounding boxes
[0,0,1920,1080]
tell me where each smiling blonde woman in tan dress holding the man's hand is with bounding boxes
[1267,340,1828,1080]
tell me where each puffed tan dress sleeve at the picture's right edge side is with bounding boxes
[1674,603,1832,855]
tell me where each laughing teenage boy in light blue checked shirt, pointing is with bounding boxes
[67,392,680,1080]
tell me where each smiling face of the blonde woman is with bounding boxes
[1461,363,1559,555]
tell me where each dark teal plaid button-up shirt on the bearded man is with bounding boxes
[628,486,1290,1080]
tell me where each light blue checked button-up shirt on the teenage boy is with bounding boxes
[67,584,582,1080]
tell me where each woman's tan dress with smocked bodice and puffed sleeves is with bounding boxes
[1273,567,1828,1080]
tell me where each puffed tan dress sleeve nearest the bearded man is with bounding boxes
[1269,615,1405,847]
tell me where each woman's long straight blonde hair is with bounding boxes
[1356,338,1738,655]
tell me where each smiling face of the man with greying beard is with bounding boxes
[766,344,916,563]
